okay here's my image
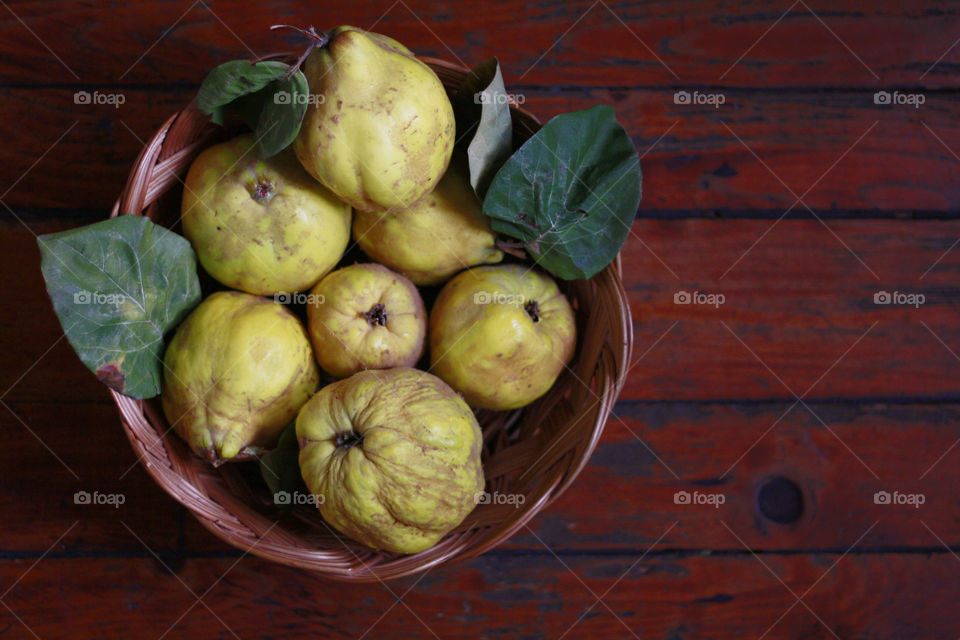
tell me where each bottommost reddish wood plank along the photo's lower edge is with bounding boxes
[0,552,960,640]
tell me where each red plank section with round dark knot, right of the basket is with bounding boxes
[524,402,960,551]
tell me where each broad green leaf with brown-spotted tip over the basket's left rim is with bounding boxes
[38,215,200,398]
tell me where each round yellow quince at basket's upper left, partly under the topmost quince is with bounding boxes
[182,135,350,295]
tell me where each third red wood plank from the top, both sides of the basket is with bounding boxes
[7,219,960,402]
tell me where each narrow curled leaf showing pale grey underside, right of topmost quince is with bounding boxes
[454,58,513,199]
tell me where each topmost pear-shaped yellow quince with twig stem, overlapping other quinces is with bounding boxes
[293,26,454,211]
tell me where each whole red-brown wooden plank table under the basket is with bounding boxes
[0,0,960,640]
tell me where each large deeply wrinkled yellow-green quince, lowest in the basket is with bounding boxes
[296,368,484,553]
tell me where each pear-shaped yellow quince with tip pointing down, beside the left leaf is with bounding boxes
[161,291,319,464]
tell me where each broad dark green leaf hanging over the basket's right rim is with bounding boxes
[483,105,641,280]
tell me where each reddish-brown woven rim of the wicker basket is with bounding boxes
[110,56,633,582]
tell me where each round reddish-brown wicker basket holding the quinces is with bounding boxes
[111,58,633,582]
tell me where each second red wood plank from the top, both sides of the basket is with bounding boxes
[7,86,960,212]
